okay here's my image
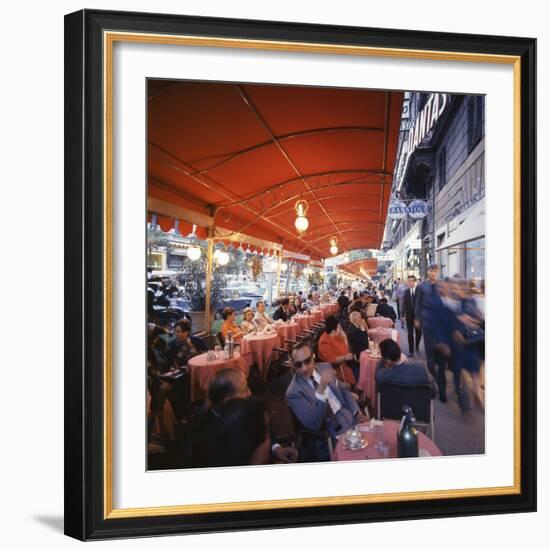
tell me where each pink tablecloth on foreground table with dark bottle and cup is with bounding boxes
[332,420,441,460]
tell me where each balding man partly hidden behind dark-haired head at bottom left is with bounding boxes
[193,368,297,466]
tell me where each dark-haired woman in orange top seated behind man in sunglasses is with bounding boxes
[318,315,359,385]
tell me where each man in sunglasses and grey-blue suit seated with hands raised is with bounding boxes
[286,343,367,462]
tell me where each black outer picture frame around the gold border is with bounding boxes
[65,10,537,540]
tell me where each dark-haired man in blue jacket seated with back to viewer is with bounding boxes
[375,338,437,397]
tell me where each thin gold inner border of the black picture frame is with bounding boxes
[103,31,521,519]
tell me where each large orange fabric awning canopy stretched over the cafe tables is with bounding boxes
[147,80,402,259]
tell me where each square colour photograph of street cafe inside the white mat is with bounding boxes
[146,78,488,471]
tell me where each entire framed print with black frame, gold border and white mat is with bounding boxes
[65,10,536,540]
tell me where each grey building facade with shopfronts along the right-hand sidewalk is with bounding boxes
[384,92,485,287]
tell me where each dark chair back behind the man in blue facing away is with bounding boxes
[377,382,435,442]
